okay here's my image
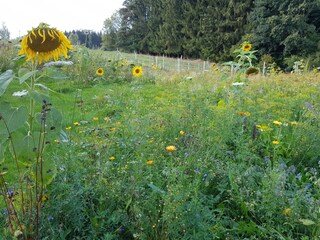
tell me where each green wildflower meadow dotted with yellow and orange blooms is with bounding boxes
[0,42,320,240]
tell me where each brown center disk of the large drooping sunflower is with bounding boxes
[27,29,61,52]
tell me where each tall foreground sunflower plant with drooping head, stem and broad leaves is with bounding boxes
[0,23,72,239]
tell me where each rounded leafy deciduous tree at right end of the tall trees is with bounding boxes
[250,0,320,58]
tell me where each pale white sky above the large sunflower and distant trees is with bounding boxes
[0,0,124,38]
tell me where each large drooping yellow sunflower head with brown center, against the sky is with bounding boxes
[19,23,72,64]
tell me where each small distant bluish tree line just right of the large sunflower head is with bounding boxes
[65,30,102,48]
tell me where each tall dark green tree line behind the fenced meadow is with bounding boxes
[102,0,320,64]
